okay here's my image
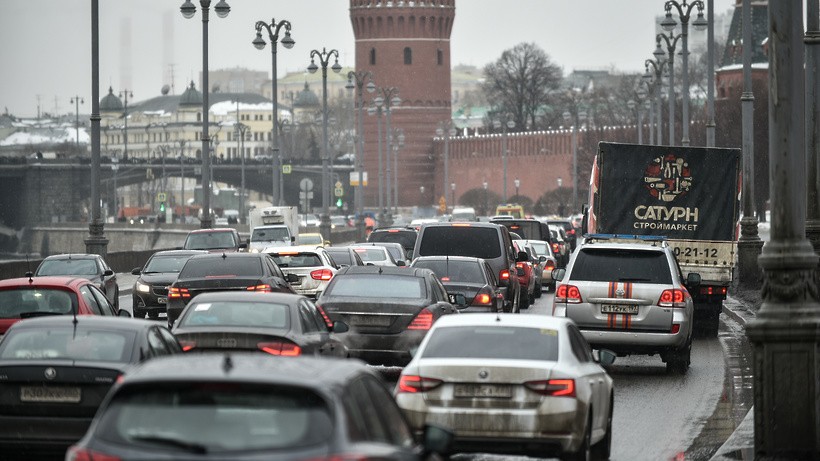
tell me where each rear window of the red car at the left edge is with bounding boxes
[0,288,78,319]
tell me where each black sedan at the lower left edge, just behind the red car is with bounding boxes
[0,315,181,459]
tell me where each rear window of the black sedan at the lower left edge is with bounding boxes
[0,328,135,362]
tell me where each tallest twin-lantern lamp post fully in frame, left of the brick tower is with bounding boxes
[252,19,296,206]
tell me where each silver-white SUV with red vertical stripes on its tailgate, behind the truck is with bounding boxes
[553,235,700,374]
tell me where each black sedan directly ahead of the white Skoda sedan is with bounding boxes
[317,266,458,365]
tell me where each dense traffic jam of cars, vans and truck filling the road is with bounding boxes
[0,143,738,461]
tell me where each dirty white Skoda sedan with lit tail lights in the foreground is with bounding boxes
[394,314,615,460]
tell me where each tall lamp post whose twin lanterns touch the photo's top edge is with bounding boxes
[179,0,231,229]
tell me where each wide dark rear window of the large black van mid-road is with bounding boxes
[417,226,502,259]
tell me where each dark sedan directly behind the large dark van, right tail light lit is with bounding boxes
[410,256,504,312]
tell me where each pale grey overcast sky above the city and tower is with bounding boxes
[0,0,734,116]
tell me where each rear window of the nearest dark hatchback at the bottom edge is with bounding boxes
[97,383,333,456]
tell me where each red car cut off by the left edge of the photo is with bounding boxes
[0,276,130,337]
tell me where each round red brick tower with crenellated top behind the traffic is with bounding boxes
[350,0,456,209]
